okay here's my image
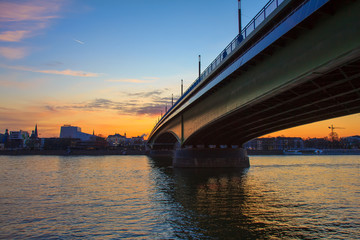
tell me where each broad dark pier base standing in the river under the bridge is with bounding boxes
[173,148,250,168]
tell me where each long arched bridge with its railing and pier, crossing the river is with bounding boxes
[148,0,360,167]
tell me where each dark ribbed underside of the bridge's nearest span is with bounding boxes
[187,56,360,145]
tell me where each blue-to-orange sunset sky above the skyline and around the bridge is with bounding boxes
[0,0,360,138]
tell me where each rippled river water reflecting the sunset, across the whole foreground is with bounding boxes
[0,156,360,239]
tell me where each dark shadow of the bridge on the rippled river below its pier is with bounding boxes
[149,157,301,239]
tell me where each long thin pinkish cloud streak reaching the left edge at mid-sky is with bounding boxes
[0,63,100,77]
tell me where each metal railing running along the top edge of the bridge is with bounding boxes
[154,0,285,132]
